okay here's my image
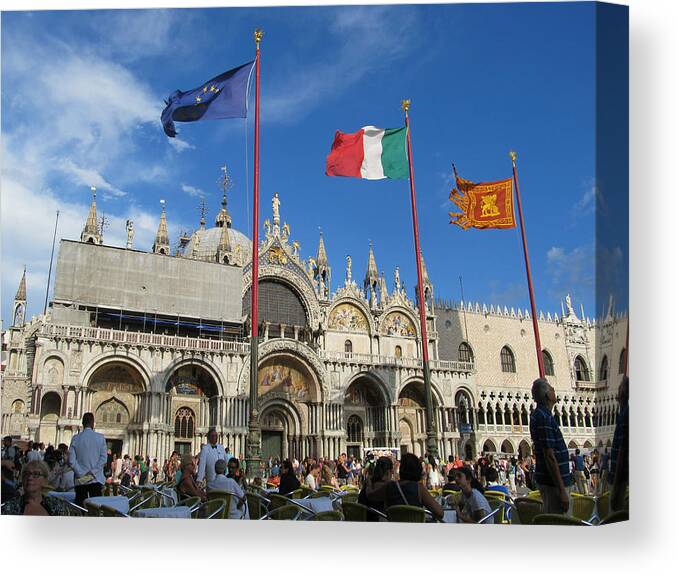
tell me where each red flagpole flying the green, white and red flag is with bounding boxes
[402,100,438,457]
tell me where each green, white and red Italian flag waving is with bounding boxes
[325,126,409,180]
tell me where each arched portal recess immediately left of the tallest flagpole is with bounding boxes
[166,363,219,453]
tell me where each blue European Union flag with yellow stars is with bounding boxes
[160,60,254,138]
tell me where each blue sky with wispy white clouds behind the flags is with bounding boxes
[2,3,628,325]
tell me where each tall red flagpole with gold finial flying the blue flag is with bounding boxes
[246,28,264,479]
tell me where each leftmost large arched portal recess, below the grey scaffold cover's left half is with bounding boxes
[85,361,145,456]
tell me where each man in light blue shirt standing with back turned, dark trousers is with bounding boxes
[68,412,108,506]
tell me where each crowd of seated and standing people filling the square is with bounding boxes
[2,378,629,522]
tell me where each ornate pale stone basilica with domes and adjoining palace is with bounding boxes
[2,187,627,462]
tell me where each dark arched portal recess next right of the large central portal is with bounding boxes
[344,377,389,457]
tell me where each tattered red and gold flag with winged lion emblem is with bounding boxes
[450,176,516,230]
